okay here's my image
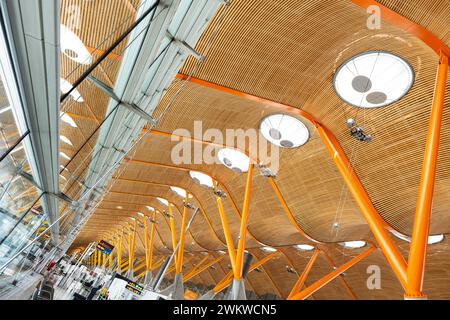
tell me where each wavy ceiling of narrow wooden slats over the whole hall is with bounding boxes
[66,0,450,299]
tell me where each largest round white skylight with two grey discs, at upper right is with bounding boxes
[333,51,414,108]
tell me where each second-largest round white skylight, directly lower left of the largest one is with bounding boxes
[259,114,309,148]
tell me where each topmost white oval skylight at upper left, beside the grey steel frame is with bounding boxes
[61,24,92,64]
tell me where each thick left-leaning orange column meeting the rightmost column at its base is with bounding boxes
[316,124,407,288]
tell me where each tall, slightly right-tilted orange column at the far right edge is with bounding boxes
[405,54,448,297]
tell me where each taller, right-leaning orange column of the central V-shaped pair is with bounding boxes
[233,161,253,280]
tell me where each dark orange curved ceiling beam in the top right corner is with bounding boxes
[352,0,450,56]
